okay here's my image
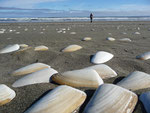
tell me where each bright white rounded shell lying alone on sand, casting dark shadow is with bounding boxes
[91,51,114,64]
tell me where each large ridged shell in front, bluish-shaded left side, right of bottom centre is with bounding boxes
[83,84,138,113]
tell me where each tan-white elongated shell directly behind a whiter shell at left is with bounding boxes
[12,63,50,76]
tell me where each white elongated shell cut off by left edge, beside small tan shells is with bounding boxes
[0,44,20,54]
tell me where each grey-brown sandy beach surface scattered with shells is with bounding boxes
[0,21,150,113]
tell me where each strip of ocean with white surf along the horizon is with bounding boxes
[0,16,150,23]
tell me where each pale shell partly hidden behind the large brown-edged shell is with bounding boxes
[84,64,117,79]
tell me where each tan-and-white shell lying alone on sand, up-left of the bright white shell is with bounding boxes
[61,44,82,52]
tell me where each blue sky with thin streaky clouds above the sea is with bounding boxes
[0,0,150,18]
